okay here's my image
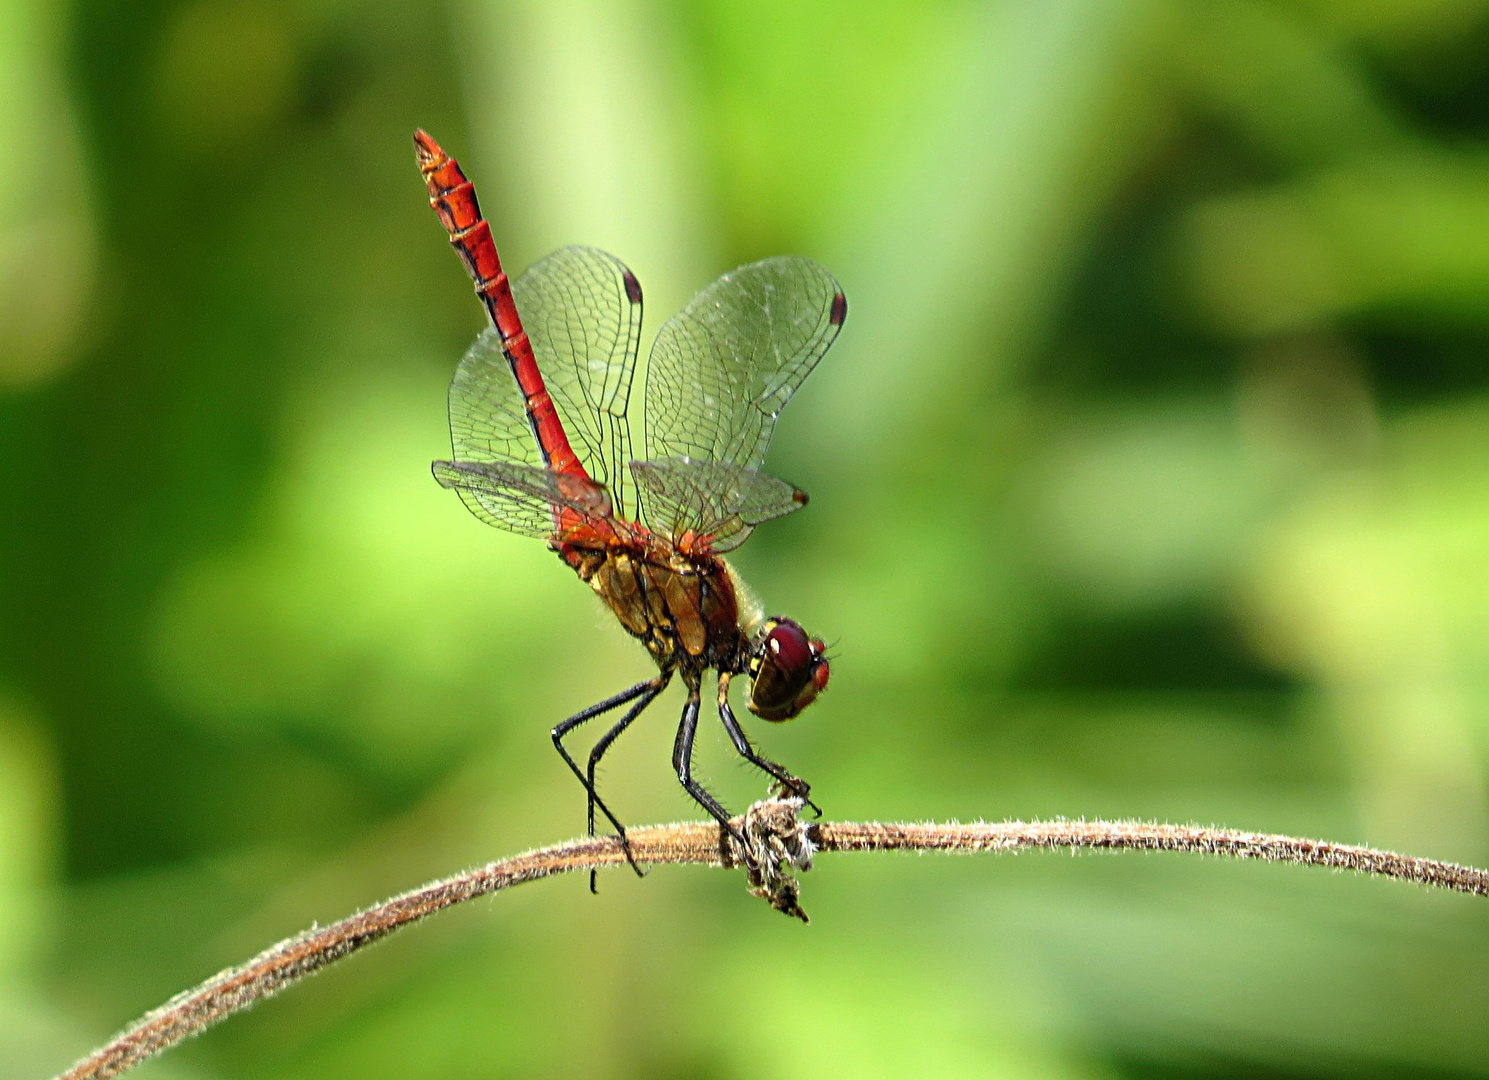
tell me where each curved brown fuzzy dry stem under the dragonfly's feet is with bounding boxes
[57,803,1489,1080]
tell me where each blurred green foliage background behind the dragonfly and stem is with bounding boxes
[0,0,1489,1080]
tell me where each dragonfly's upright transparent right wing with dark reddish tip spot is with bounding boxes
[645,256,847,469]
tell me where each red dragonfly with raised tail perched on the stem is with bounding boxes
[414,130,847,889]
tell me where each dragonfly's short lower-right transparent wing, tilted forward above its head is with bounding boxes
[631,457,807,551]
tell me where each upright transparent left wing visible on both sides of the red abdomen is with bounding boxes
[450,247,642,512]
